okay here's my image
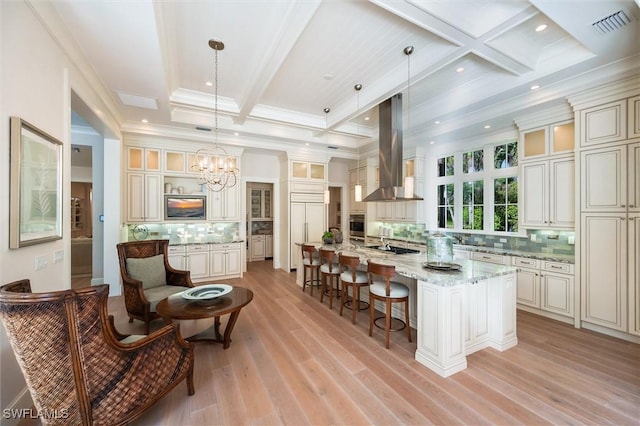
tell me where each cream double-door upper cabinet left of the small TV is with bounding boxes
[127,173,164,222]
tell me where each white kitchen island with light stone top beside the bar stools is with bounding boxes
[298,243,518,377]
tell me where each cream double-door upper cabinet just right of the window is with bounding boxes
[520,156,575,229]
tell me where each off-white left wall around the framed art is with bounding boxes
[0,0,120,414]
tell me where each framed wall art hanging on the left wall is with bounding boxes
[9,117,62,249]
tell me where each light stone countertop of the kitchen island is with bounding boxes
[297,242,518,287]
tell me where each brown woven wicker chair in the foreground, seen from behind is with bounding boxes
[0,280,194,425]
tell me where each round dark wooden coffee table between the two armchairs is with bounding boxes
[156,287,253,349]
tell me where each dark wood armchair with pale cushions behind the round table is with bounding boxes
[116,240,193,334]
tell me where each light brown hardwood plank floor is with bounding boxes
[104,262,640,425]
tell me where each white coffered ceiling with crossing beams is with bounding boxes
[46,0,640,158]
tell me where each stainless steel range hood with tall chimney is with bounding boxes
[362,93,423,201]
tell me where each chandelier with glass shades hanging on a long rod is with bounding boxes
[191,39,238,192]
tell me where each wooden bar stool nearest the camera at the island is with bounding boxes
[367,261,411,349]
